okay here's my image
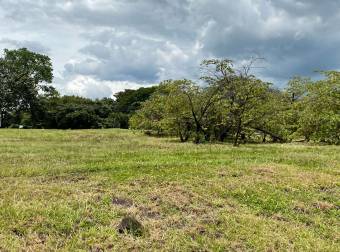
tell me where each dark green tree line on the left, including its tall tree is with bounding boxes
[0,48,156,129]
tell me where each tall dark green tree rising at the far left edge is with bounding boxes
[0,48,53,127]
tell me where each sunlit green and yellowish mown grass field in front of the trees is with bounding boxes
[0,130,340,251]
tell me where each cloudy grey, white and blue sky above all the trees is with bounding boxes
[0,0,340,98]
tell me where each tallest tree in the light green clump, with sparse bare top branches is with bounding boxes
[203,59,270,146]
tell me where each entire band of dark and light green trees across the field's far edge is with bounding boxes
[0,48,340,145]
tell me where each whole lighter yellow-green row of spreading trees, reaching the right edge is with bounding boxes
[130,59,340,146]
